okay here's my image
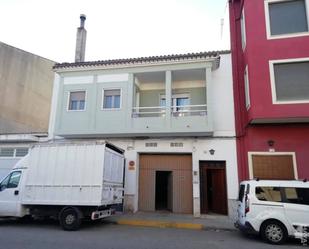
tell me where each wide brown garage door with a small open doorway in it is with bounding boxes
[138,154,193,214]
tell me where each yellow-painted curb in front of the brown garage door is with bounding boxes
[111,219,236,231]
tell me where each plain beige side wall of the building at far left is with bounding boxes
[0,42,55,134]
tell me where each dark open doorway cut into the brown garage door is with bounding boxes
[155,171,173,211]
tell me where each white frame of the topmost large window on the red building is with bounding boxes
[264,0,309,40]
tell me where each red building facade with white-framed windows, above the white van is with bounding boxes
[229,0,309,180]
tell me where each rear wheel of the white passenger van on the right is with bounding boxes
[261,220,288,245]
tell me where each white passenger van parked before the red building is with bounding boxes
[235,180,309,244]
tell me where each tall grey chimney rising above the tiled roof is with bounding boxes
[75,14,87,62]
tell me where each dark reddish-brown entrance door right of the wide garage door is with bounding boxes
[200,161,227,215]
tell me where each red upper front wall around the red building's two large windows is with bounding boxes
[244,0,309,120]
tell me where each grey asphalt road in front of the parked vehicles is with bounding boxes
[0,220,304,249]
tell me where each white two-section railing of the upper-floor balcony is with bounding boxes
[132,105,207,118]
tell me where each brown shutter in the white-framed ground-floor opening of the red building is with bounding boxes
[252,155,295,180]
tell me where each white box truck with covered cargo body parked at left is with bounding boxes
[0,142,125,230]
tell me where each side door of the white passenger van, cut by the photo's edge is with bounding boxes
[283,187,309,228]
